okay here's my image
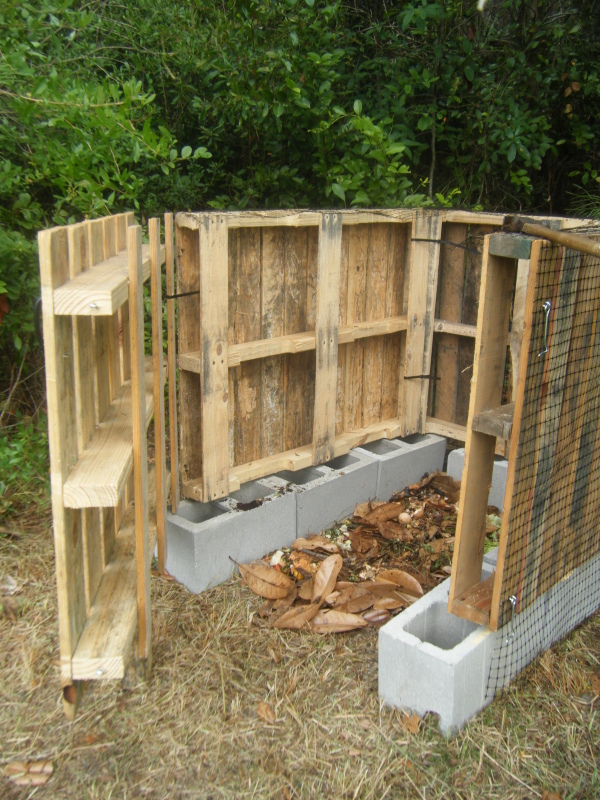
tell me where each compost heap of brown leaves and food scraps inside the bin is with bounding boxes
[238,472,500,633]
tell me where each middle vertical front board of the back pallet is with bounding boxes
[313,213,342,464]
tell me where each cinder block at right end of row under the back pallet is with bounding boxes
[352,433,446,501]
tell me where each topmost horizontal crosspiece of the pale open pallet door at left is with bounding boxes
[54,244,165,317]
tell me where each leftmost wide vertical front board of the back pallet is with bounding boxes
[200,214,229,500]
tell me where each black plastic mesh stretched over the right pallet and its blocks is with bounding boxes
[488,236,600,694]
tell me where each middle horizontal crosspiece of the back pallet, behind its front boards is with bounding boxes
[178,316,408,374]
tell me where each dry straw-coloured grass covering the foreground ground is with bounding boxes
[0,519,600,800]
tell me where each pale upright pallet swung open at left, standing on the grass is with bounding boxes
[38,214,166,716]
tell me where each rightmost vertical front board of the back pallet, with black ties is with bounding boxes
[403,210,442,436]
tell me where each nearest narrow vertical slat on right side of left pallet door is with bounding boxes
[127,225,152,672]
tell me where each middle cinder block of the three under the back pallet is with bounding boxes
[276,451,377,537]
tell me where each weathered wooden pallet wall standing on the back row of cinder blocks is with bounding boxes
[175,209,502,501]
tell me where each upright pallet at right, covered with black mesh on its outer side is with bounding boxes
[449,234,600,630]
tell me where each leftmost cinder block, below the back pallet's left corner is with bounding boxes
[166,480,296,593]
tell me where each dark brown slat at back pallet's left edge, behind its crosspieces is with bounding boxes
[175,225,202,483]
